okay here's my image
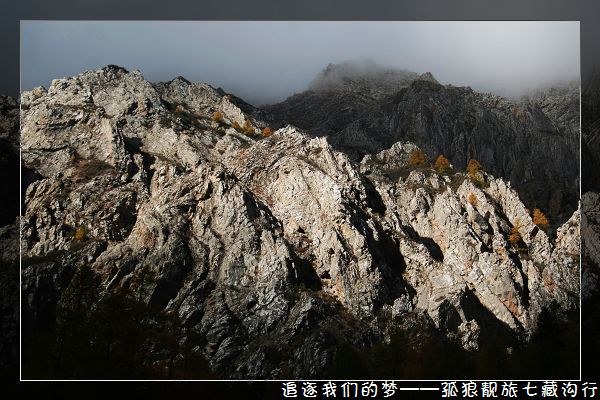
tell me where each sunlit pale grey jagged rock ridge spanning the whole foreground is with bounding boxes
[21,66,579,378]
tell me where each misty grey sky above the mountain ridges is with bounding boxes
[21,21,580,105]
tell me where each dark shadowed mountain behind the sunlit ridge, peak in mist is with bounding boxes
[268,66,579,223]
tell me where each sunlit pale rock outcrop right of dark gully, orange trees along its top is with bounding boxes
[362,144,579,330]
